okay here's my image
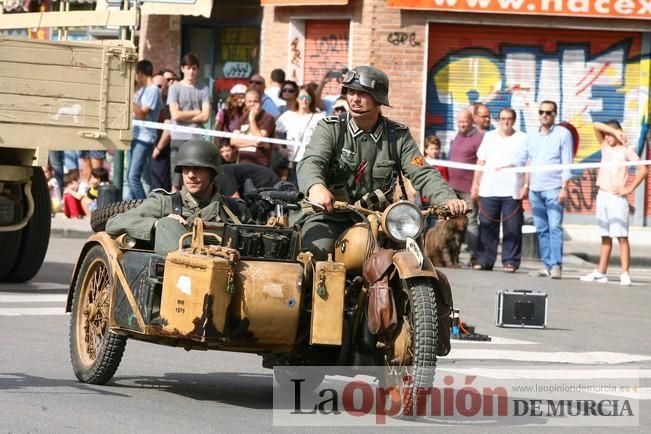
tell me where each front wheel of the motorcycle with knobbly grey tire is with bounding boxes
[385,279,438,416]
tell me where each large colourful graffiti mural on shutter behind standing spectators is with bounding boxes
[425,24,649,212]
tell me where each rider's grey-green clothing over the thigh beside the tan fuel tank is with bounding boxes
[301,213,359,261]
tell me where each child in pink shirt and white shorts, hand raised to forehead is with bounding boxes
[581,120,648,286]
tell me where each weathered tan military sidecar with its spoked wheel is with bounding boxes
[66,221,345,384]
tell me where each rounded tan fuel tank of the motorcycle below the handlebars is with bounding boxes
[335,223,375,274]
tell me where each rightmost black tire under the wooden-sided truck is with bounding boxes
[2,167,52,282]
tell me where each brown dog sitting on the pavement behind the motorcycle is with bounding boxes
[425,215,468,268]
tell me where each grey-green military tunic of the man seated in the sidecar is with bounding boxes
[106,187,250,255]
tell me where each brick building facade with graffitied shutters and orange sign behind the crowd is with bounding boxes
[260,0,651,226]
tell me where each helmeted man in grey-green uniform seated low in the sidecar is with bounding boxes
[106,140,250,255]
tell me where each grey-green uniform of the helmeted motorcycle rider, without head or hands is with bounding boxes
[298,115,457,259]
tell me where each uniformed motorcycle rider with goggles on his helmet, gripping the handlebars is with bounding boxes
[298,66,467,260]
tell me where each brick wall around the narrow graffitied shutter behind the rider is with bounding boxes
[260,0,426,143]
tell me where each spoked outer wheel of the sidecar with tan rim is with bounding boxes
[70,245,127,384]
